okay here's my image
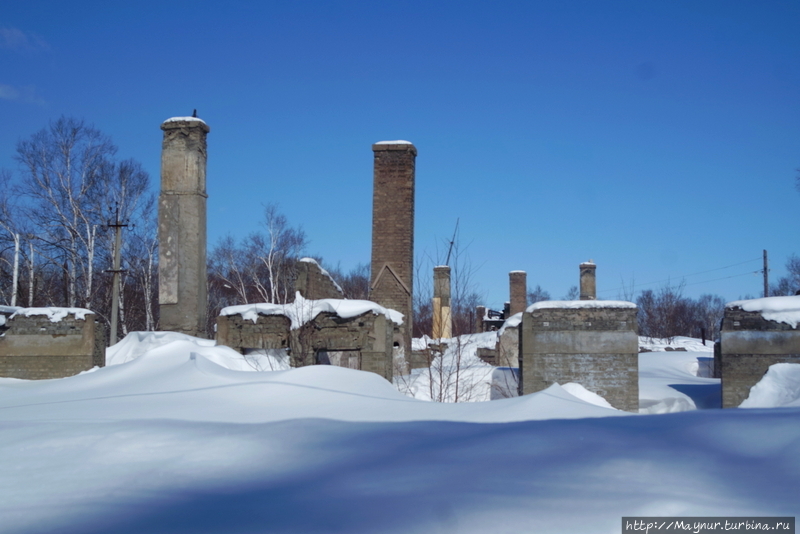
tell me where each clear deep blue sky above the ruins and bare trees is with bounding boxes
[0,0,800,308]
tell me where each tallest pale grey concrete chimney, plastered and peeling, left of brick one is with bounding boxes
[158,117,210,337]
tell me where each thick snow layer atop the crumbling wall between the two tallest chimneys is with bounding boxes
[220,293,403,330]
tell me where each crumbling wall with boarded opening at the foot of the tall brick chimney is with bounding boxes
[217,311,396,381]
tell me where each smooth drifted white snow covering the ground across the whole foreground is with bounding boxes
[0,337,800,534]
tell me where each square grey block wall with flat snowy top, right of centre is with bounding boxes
[520,307,639,412]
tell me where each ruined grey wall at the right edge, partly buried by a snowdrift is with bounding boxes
[715,308,800,408]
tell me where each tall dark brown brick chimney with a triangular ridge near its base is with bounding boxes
[370,141,417,358]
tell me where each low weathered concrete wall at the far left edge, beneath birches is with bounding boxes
[0,314,106,380]
